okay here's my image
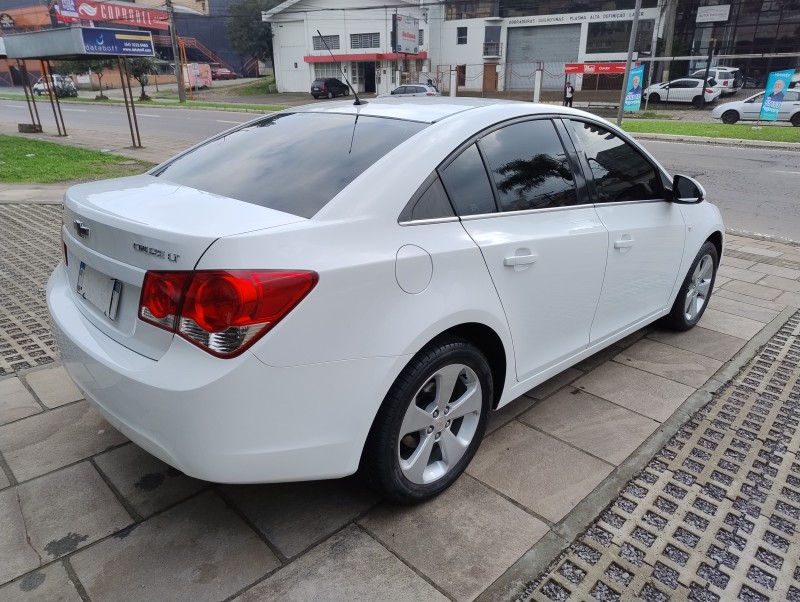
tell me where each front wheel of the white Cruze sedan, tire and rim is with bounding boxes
[664,241,719,331]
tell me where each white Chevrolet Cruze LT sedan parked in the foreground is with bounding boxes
[47,98,724,502]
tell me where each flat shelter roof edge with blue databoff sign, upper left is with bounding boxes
[3,27,155,59]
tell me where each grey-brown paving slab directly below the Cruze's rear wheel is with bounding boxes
[360,474,548,600]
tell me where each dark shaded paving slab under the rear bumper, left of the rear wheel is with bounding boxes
[223,478,379,558]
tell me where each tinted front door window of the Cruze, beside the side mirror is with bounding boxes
[572,121,664,203]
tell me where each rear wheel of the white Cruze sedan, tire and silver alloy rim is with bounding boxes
[360,337,493,504]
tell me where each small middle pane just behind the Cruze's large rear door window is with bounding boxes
[442,144,496,215]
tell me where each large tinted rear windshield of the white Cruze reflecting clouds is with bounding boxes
[154,113,427,218]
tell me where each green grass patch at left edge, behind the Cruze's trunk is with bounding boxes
[0,135,153,184]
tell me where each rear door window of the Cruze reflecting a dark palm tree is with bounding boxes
[481,119,578,211]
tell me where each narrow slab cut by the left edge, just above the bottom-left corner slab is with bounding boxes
[0,489,40,580]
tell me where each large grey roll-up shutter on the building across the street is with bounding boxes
[506,24,581,90]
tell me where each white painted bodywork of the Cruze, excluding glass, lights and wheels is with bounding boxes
[47,99,723,483]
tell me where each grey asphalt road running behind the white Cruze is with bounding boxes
[0,101,800,241]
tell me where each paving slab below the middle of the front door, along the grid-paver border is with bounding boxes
[574,362,695,422]
